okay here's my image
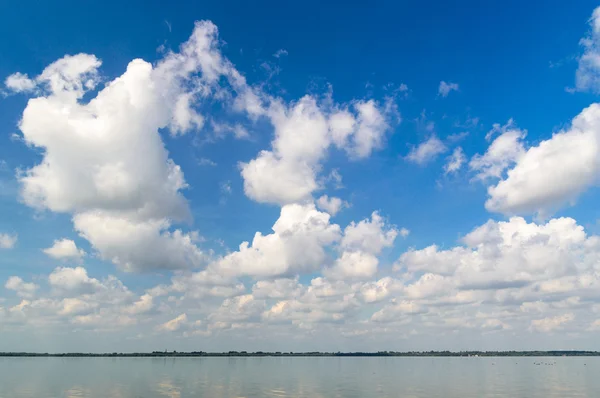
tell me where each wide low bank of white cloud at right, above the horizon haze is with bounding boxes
[395,217,600,297]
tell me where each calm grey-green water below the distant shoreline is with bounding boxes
[0,357,600,398]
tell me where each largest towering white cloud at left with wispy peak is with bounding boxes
[8,21,261,271]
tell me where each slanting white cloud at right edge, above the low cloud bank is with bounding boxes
[480,104,600,216]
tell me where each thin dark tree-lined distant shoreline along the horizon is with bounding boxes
[0,351,600,358]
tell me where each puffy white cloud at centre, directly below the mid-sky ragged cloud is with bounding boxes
[216,203,341,276]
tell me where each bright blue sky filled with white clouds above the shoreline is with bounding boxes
[0,0,600,352]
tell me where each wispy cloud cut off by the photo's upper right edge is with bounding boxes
[575,7,600,93]
